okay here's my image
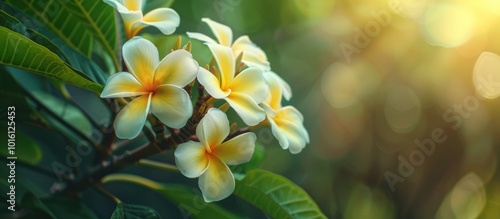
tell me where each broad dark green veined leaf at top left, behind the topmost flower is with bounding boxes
[7,0,120,68]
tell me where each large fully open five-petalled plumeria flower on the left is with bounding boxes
[101,37,199,139]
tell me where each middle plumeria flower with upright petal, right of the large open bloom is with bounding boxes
[198,43,268,125]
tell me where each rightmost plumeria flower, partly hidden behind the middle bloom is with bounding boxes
[261,74,309,154]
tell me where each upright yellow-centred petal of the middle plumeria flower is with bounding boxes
[205,43,235,90]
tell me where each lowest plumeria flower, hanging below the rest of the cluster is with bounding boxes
[174,108,257,202]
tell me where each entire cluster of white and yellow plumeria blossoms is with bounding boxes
[101,0,309,202]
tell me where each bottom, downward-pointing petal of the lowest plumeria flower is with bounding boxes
[198,156,235,202]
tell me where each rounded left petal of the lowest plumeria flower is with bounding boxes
[174,141,209,178]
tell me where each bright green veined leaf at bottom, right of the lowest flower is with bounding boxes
[234,169,326,218]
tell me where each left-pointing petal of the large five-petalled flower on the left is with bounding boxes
[101,72,148,98]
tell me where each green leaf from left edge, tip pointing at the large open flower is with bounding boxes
[0,27,103,93]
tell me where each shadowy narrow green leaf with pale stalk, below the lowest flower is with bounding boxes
[102,174,240,219]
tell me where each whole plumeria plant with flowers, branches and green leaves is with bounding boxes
[0,0,324,218]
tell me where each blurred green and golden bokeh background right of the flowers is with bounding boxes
[173,0,500,218]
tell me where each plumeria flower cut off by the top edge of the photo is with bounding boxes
[104,0,180,39]
